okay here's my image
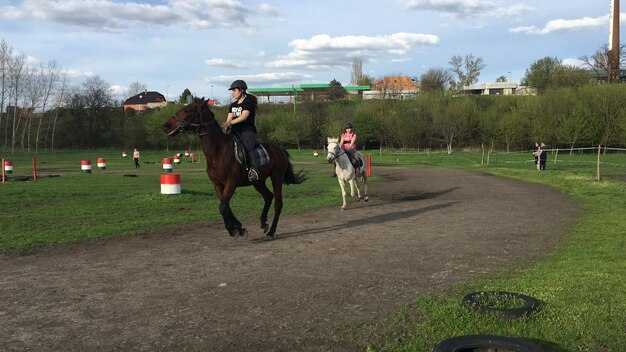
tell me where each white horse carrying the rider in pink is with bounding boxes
[326,138,369,210]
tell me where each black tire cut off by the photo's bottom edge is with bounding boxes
[434,335,544,352]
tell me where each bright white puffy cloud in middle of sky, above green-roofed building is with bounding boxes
[267,32,439,69]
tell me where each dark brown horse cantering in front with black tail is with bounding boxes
[163,98,304,238]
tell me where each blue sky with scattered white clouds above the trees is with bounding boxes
[0,0,626,102]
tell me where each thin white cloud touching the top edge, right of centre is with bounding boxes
[403,0,533,18]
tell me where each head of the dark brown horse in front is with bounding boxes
[163,98,217,136]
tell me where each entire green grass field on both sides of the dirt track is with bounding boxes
[0,150,626,351]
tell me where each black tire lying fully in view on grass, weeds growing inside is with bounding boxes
[463,291,541,318]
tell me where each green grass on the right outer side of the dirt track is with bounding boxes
[360,153,626,351]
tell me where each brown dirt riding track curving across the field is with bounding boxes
[0,167,576,351]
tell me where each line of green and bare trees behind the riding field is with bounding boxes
[0,35,626,153]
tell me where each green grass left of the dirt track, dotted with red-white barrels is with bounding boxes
[0,151,341,252]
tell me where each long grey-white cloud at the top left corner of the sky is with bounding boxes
[0,0,246,31]
